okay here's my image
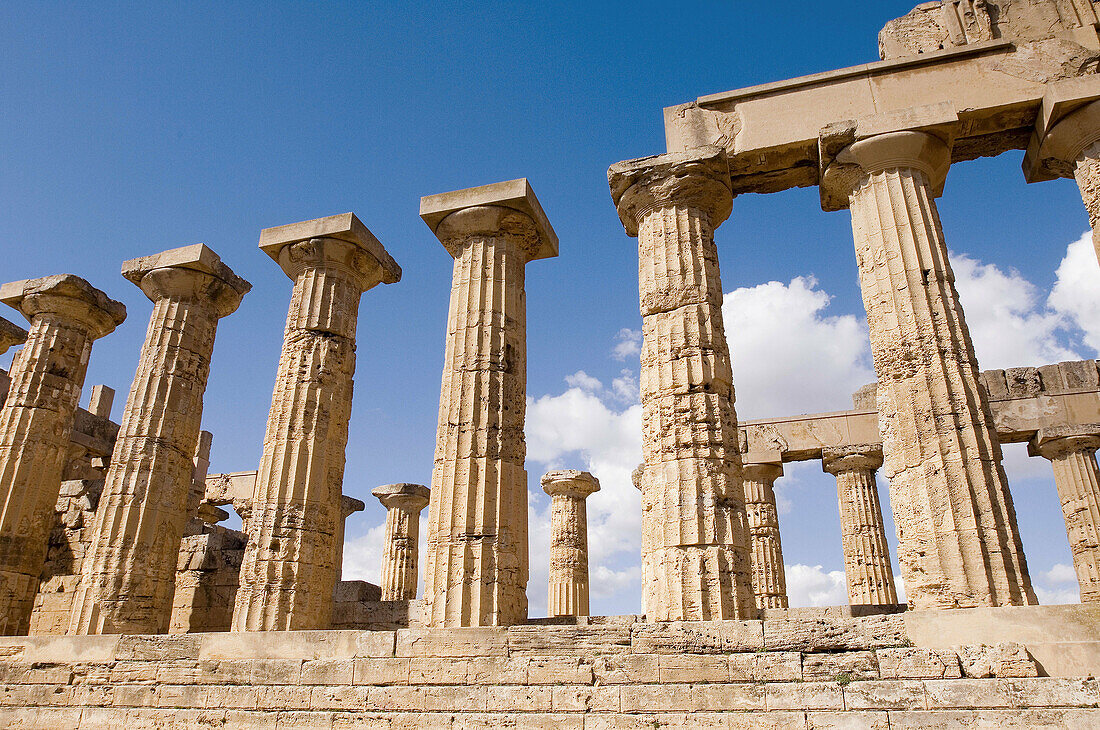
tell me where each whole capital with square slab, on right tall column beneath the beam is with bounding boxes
[817,101,959,211]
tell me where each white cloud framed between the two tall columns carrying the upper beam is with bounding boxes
[722,276,875,419]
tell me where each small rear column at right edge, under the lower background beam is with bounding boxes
[1030,423,1100,604]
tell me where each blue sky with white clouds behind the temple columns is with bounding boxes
[0,0,1100,616]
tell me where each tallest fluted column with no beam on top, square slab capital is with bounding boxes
[420,179,558,627]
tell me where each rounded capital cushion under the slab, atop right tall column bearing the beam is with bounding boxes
[821,131,952,211]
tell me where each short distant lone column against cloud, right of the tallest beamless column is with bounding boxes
[541,469,600,617]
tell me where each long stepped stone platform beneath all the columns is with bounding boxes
[0,606,1100,730]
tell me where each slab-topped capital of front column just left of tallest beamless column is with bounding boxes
[260,213,402,291]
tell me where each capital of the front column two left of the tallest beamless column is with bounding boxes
[122,243,252,317]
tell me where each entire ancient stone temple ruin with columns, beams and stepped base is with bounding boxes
[0,0,1100,730]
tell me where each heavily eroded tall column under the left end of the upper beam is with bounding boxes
[607,147,757,621]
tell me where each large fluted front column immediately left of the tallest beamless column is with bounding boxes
[233,213,402,631]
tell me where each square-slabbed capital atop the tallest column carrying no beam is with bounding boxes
[420,177,558,261]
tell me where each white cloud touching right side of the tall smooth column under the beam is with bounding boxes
[950,253,1078,369]
